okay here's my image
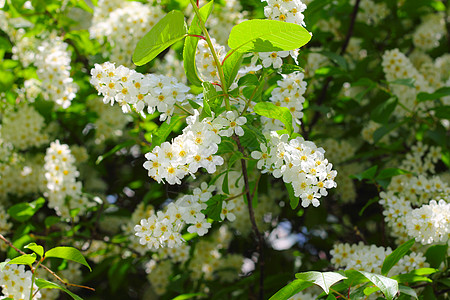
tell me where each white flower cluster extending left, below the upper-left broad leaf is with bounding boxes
[91,62,189,121]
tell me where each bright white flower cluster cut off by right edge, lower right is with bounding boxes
[405,200,450,245]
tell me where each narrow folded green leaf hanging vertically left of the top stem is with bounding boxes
[183,1,214,86]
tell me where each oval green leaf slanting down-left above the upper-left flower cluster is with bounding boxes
[133,10,188,66]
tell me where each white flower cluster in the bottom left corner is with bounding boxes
[0,259,41,299]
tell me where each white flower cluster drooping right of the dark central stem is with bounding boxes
[251,131,337,207]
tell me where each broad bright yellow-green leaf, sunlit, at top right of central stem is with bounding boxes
[228,20,311,53]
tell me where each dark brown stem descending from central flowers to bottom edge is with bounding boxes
[233,135,264,300]
